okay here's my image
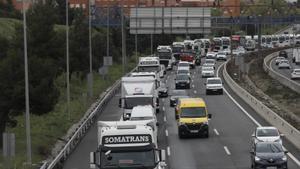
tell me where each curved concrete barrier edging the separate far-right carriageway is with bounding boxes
[263,52,300,94]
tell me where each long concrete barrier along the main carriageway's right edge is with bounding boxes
[223,62,300,149]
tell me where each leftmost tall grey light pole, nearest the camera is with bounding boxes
[22,0,32,166]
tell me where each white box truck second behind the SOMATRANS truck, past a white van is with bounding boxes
[119,77,159,120]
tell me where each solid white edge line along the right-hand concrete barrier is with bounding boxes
[217,62,300,167]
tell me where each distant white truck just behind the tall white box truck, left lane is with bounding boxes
[137,57,164,77]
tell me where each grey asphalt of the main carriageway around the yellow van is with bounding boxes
[63,58,300,169]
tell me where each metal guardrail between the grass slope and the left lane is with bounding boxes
[40,68,136,169]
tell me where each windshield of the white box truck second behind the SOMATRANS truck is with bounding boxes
[125,97,153,109]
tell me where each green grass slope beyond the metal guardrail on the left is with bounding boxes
[4,63,136,168]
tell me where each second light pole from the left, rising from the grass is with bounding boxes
[66,0,71,121]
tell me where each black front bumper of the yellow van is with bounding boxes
[178,124,209,135]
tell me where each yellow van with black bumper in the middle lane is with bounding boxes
[175,98,211,138]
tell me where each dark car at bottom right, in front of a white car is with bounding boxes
[251,142,288,169]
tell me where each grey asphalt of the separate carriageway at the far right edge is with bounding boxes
[269,50,300,85]
